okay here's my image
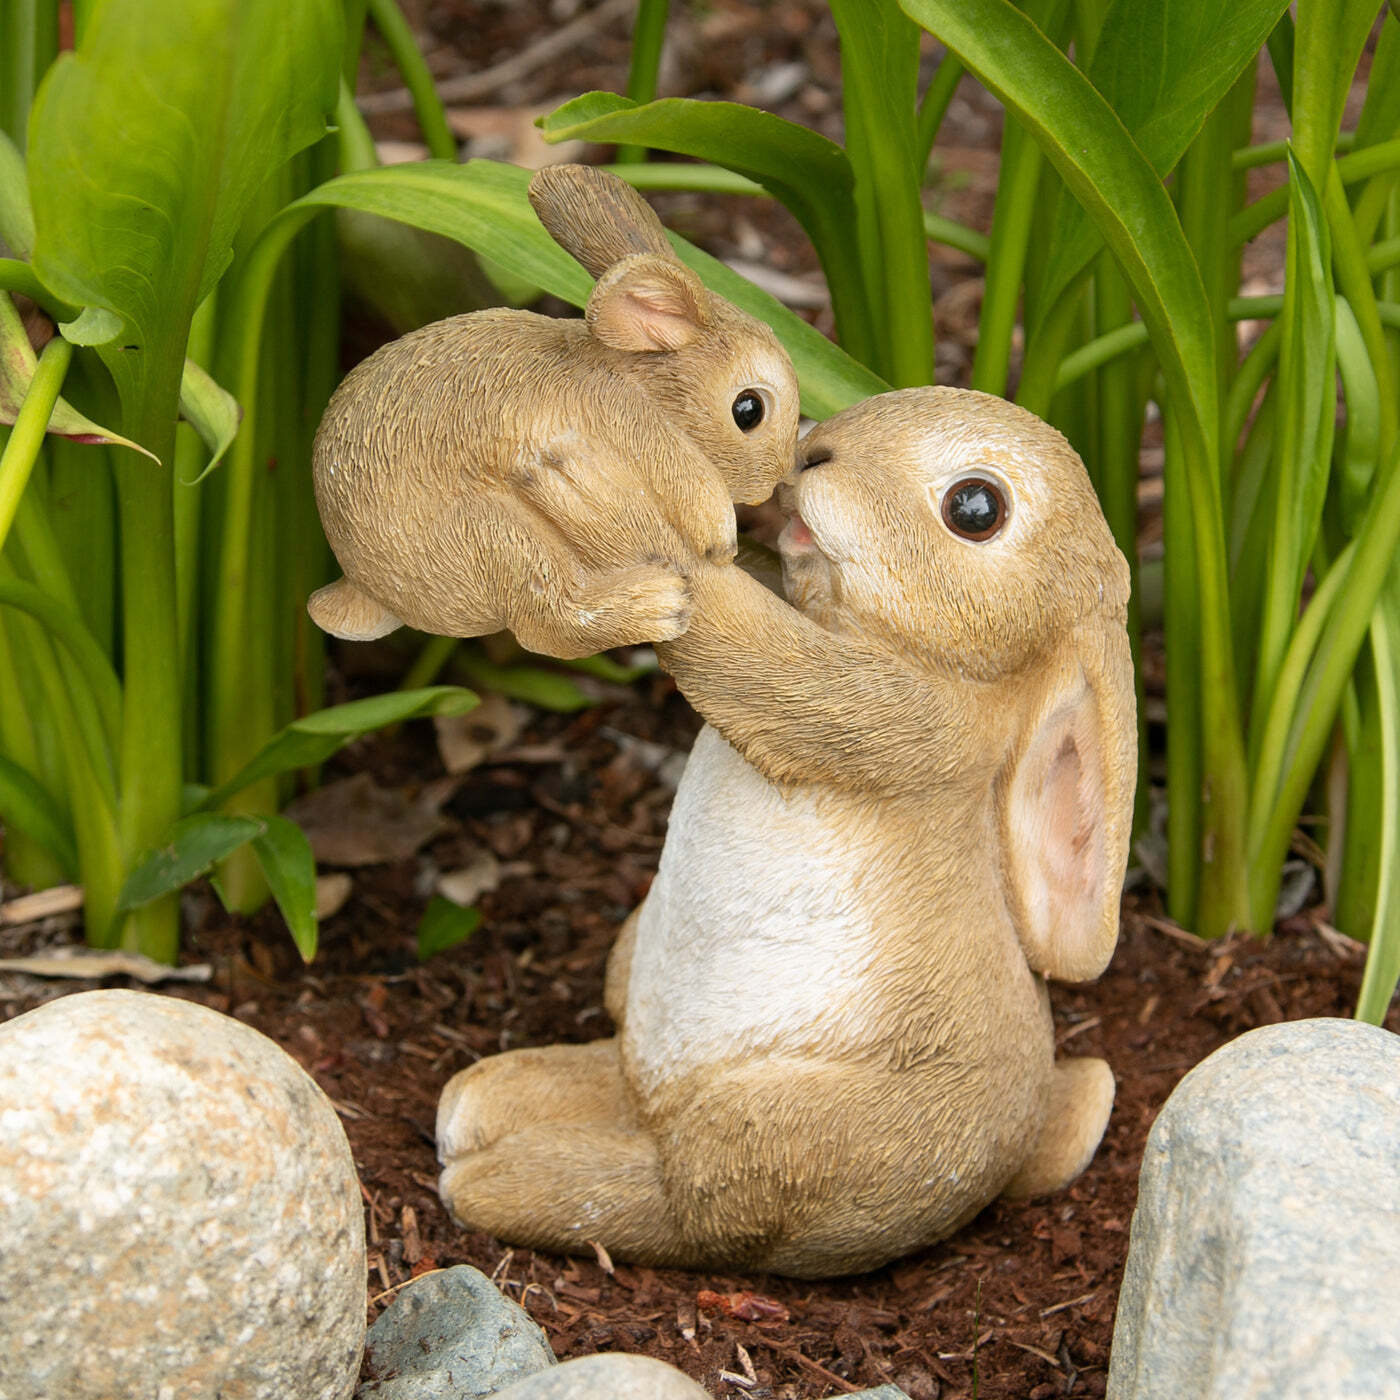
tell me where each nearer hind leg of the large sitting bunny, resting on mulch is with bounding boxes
[438,1123,697,1268]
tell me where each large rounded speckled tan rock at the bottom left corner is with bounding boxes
[0,991,365,1400]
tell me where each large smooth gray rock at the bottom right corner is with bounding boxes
[1109,1021,1400,1400]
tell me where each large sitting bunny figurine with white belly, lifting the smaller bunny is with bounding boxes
[437,389,1135,1278]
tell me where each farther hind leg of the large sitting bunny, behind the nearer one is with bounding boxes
[437,1040,636,1168]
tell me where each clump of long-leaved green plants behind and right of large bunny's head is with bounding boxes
[526,0,1400,1019]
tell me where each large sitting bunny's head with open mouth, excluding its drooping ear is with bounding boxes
[780,388,1128,680]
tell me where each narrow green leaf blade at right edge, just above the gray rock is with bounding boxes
[1357,568,1400,1026]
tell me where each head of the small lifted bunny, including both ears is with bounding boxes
[529,165,799,503]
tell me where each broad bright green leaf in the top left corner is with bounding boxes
[28,0,343,425]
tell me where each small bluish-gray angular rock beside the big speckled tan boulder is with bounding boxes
[356,1264,554,1400]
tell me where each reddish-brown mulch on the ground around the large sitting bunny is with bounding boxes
[0,678,1400,1400]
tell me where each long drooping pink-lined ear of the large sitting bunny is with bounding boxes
[1001,617,1137,981]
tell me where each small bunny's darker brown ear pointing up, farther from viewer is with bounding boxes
[529,165,675,277]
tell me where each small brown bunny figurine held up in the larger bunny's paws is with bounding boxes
[308,165,798,657]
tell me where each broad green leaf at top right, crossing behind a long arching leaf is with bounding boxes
[1028,0,1287,336]
